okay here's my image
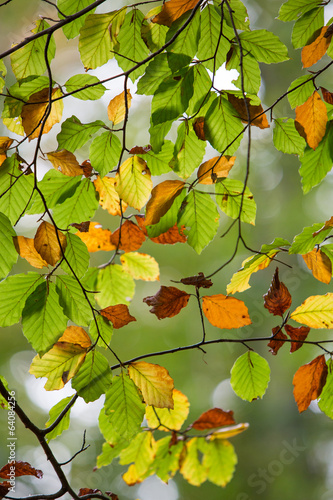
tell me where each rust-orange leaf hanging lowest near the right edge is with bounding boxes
[293,354,327,413]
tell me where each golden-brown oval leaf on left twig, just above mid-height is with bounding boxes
[34,221,67,266]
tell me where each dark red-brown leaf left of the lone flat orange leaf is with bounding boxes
[143,286,190,319]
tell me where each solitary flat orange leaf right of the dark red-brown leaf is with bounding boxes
[202,294,252,329]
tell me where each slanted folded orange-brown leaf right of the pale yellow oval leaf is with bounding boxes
[145,181,185,226]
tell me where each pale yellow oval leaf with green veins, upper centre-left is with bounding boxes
[115,156,153,210]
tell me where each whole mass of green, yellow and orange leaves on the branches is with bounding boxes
[0,0,333,499]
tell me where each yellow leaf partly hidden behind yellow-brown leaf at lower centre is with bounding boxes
[146,389,190,432]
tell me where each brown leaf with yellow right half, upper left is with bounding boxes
[21,88,64,141]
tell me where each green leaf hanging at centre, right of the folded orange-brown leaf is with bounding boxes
[178,190,219,254]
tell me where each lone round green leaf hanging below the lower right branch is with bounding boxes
[230,351,270,401]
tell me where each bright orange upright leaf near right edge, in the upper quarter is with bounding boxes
[295,91,327,149]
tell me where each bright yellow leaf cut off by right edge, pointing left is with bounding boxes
[290,293,333,328]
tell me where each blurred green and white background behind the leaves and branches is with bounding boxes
[0,0,333,500]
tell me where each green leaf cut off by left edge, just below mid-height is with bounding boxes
[0,273,44,326]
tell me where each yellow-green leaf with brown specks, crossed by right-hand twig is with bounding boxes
[215,179,257,225]
